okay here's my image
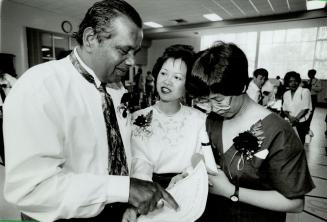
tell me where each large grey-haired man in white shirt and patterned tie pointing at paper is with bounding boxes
[4,0,178,221]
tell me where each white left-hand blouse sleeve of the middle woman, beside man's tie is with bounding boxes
[131,112,153,181]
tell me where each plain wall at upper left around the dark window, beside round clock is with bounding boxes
[0,0,80,76]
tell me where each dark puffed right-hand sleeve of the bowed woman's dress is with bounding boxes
[266,126,314,199]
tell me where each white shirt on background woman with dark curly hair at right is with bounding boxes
[283,86,312,122]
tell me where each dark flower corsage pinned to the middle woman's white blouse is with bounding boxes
[133,110,153,137]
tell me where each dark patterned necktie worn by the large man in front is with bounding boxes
[70,52,128,176]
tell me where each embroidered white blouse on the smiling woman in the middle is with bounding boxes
[132,106,209,180]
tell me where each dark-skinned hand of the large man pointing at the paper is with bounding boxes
[128,178,179,214]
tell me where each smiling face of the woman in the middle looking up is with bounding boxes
[157,58,187,102]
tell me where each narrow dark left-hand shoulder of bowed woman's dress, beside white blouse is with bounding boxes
[206,113,224,162]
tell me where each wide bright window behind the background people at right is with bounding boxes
[201,27,327,79]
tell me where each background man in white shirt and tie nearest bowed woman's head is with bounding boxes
[246,68,268,105]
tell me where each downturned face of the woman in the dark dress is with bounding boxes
[194,93,243,118]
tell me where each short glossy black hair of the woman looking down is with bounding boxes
[186,41,249,97]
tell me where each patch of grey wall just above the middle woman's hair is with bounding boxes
[143,37,200,72]
